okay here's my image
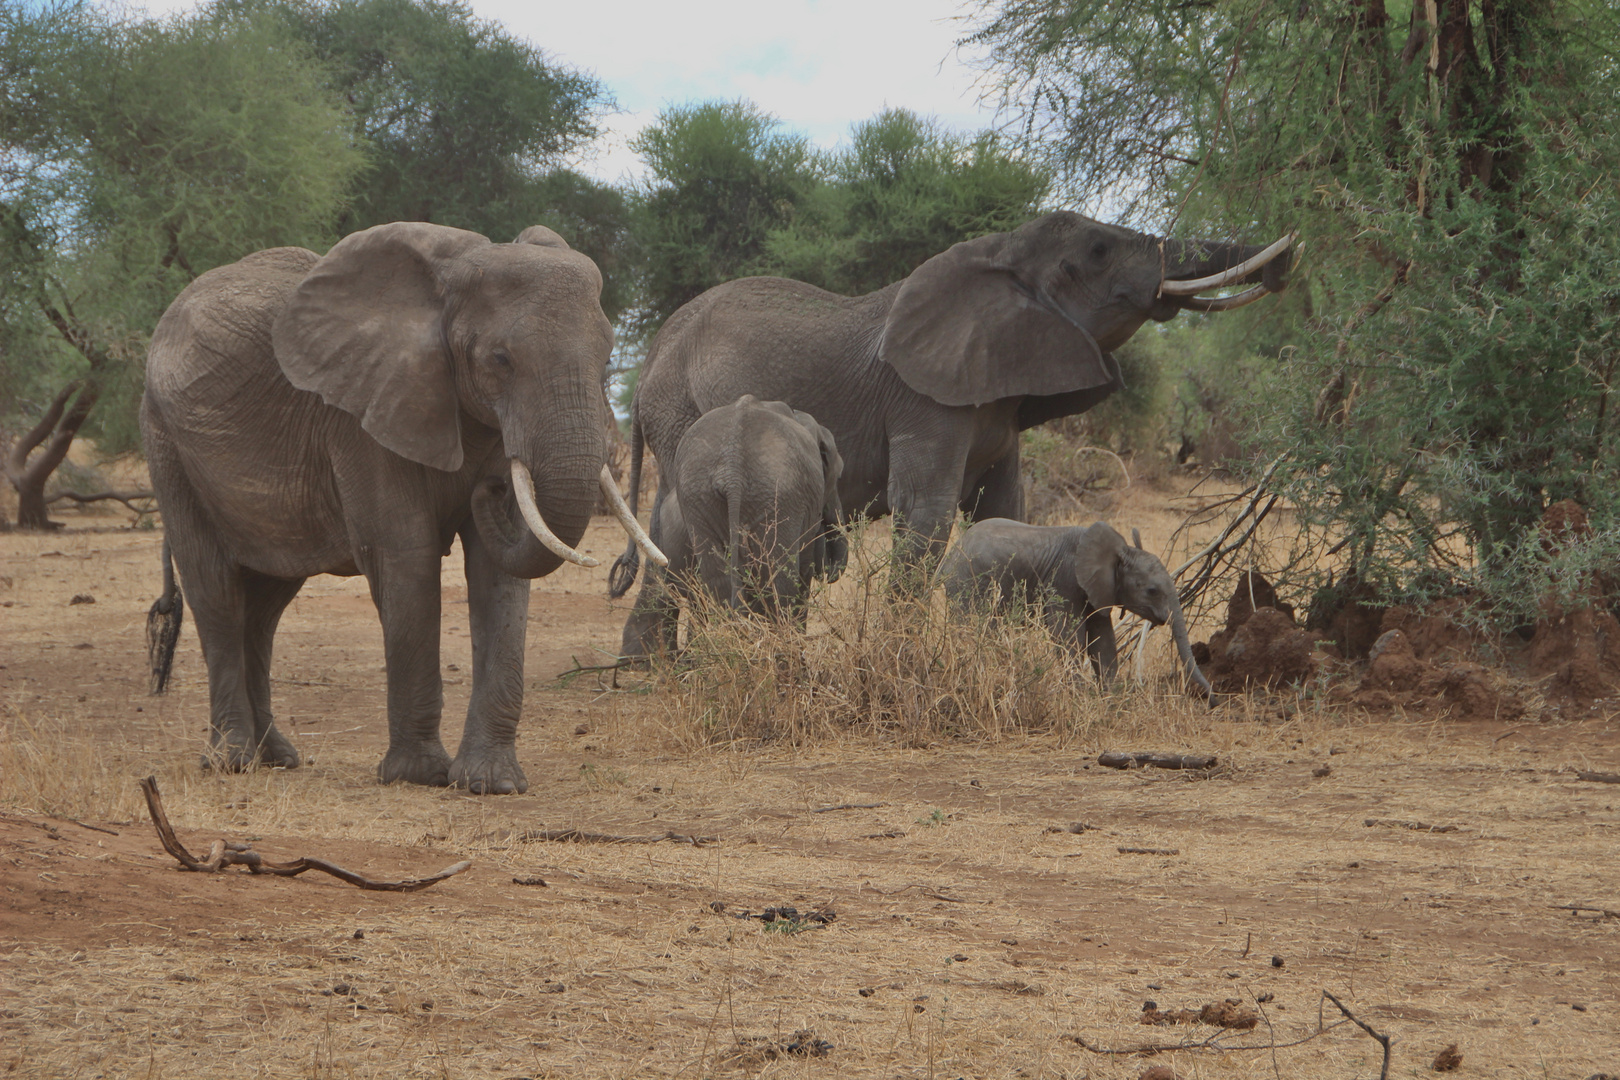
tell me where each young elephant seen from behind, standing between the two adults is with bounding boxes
[620,393,849,657]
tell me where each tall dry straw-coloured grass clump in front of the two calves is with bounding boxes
[658,524,1198,746]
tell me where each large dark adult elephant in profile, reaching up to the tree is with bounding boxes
[611,212,1290,596]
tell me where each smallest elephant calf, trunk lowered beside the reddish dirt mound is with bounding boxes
[940,518,1210,698]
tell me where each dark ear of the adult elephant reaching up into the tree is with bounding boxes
[880,233,1113,405]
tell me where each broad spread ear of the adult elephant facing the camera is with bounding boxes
[271,222,489,471]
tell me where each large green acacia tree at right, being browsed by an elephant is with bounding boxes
[970,0,1620,617]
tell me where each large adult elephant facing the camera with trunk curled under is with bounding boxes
[141,222,661,792]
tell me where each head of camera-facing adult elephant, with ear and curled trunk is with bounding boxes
[271,222,657,578]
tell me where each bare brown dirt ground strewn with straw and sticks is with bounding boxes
[0,489,1620,1080]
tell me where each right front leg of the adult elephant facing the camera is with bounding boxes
[450,528,528,795]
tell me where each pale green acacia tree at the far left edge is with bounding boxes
[0,0,361,528]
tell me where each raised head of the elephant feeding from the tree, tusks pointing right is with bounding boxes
[880,210,1293,427]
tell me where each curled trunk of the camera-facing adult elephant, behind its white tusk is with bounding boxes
[473,427,603,578]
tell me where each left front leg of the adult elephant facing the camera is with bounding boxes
[361,549,450,787]
